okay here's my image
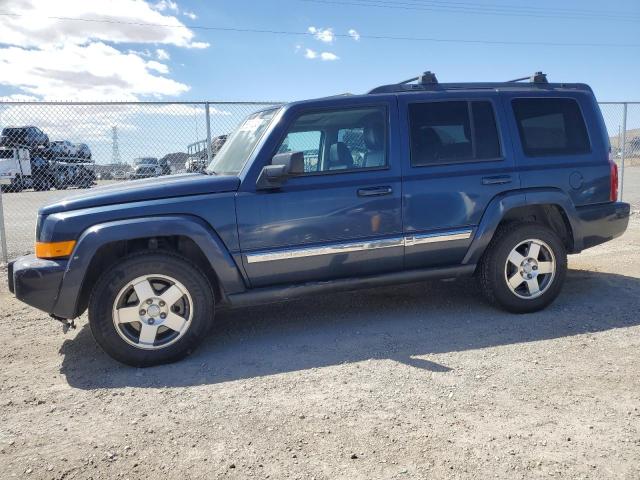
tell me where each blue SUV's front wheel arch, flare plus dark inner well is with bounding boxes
[54,215,246,318]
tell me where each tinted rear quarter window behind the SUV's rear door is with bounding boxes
[511,98,591,157]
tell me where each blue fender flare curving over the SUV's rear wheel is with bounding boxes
[462,188,583,265]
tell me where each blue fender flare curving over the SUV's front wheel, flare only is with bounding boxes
[53,215,245,318]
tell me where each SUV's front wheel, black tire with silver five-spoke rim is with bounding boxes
[89,252,215,367]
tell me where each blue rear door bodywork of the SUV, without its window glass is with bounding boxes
[398,91,520,269]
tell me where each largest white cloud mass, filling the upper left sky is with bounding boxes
[0,0,209,100]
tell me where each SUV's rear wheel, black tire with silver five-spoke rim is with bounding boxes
[478,222,567,313]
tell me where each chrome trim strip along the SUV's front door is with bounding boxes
[246,237,404,263]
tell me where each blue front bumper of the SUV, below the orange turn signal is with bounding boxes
[9,255,67,313]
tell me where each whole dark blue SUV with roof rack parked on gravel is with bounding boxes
[9,72,629,366]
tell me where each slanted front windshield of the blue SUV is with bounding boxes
[207,108,279,175]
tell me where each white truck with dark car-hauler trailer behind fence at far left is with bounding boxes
[0,147,95,192]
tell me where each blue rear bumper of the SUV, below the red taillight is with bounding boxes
[576,202,631,250]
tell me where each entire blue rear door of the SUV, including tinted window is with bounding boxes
[399,91,520,269]
